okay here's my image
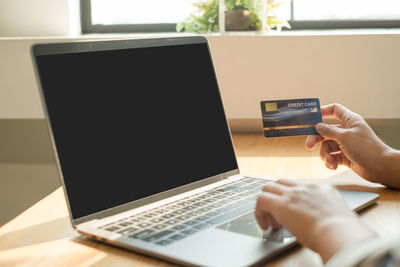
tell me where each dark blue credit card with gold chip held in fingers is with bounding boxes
[260,98,322,138]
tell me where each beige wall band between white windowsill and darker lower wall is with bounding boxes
[0,34,400,119]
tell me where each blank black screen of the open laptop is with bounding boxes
[35,38,238,222]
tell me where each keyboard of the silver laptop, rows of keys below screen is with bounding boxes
[99,177,268,246]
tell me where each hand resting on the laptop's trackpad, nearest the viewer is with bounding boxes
[255,180,375,262]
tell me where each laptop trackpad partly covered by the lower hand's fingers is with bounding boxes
[217,211,295,243]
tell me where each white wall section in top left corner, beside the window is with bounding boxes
[0,0,71,37]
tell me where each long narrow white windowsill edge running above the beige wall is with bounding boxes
[0,29,400,40]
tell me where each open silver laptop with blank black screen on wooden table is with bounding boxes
[32,36,377,267]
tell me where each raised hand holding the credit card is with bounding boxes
[305,104,400,188]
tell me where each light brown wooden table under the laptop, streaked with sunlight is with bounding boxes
[0,134,400,266]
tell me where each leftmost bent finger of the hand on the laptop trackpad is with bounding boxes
[254,192,280,230]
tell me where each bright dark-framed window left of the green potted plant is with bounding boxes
[81,0,194,33]
